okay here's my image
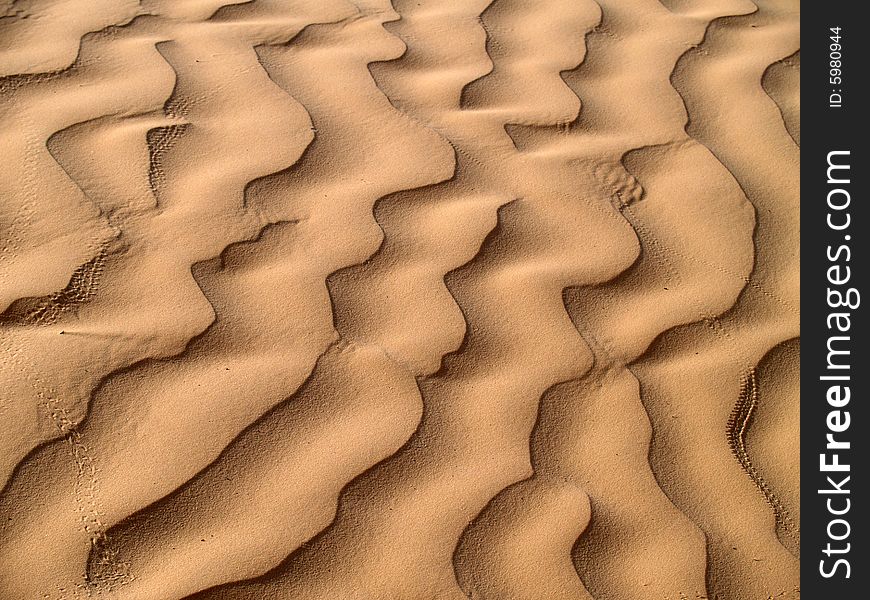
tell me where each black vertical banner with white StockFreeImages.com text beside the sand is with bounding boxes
[801,0,870,600]
